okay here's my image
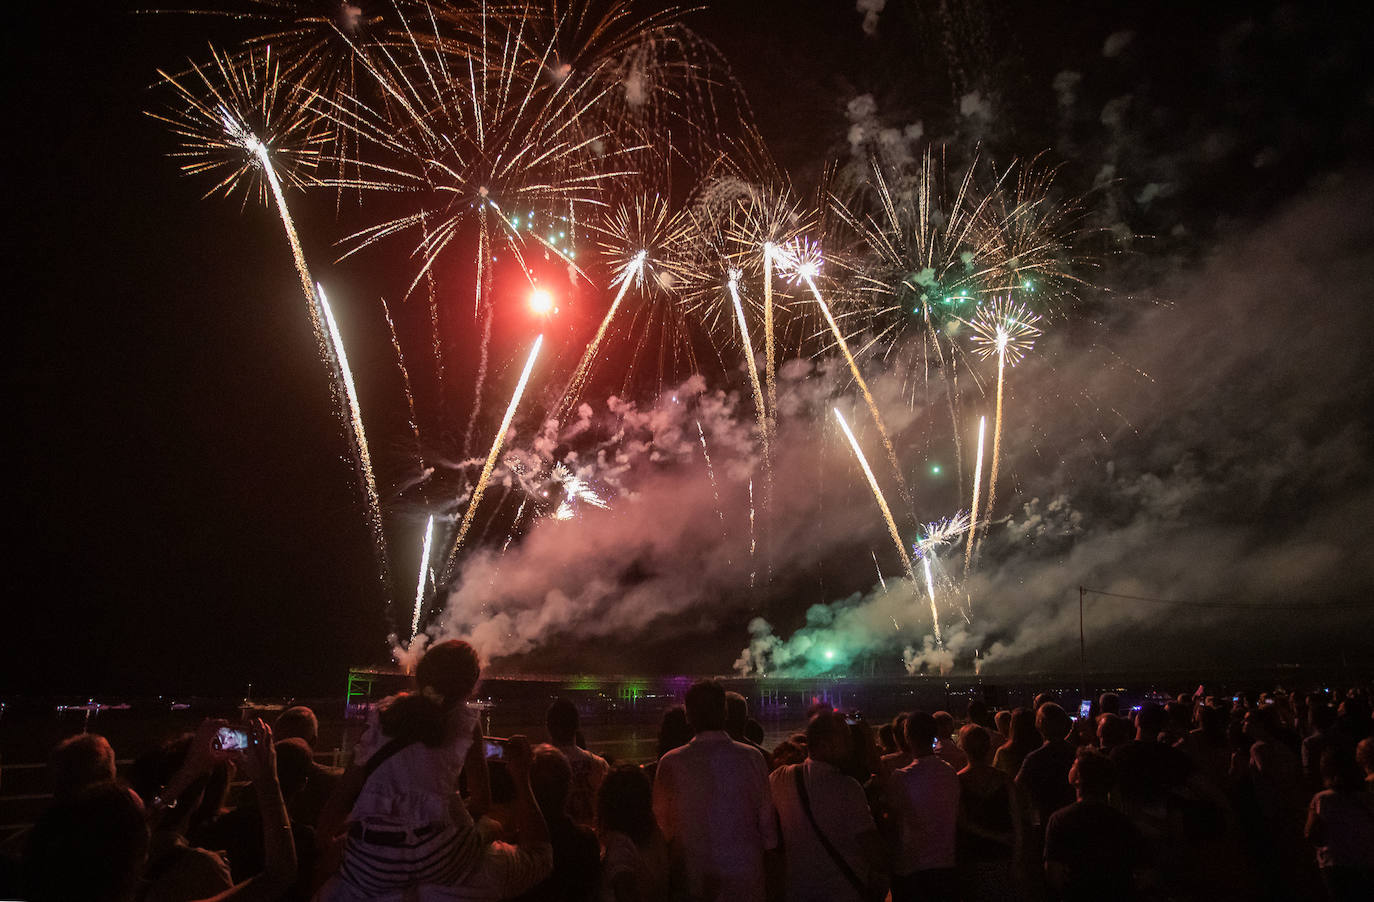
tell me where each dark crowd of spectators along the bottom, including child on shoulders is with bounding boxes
[0,641,1374,902]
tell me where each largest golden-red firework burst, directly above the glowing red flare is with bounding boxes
[317,8,631,299]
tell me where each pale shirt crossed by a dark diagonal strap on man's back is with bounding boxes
[768,758,878,902]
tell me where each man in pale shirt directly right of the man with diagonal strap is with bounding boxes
[888,711,959,902]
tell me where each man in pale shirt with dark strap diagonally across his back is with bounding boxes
[768,711,886,902]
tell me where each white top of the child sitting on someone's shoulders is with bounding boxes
[349,693,478,829]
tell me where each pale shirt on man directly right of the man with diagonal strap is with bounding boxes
[888,755,959,875]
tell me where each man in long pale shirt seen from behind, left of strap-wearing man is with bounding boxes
[654,679,778,902]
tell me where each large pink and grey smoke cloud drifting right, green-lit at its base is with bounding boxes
[429,182,1374,674]
